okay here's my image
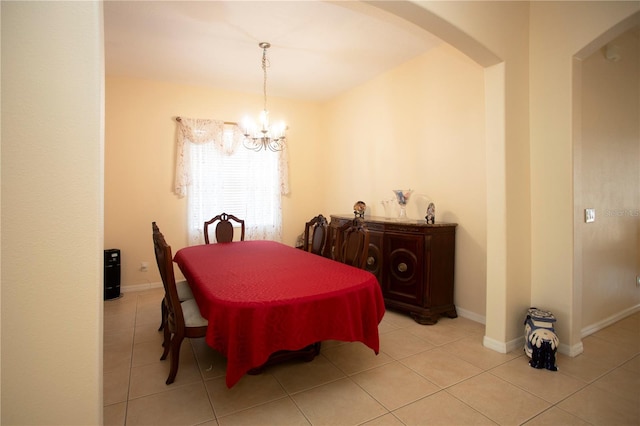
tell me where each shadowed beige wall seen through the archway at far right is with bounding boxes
[576,28,640,332]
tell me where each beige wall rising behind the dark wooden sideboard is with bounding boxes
[323,44,487,321]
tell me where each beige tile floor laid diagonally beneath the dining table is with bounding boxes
[104,290,640,426]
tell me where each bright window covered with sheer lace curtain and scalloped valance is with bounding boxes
[174,118,289,244]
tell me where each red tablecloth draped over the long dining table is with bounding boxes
[174,241,385,387]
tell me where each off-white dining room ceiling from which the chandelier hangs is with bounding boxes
[104,0,442,101]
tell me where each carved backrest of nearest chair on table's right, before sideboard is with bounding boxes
[334,218,369,269]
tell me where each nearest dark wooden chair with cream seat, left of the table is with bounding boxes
[152,222,208,385]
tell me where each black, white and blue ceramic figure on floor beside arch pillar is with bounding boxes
[524,307,560,371]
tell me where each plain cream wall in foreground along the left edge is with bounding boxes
[0,2,104,425]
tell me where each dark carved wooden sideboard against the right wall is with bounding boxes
[330,215,458,324]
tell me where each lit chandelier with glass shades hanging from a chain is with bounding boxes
[243,41,286,152]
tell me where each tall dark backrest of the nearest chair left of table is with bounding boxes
[151,222,184,330]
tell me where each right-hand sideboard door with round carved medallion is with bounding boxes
[383,232,425,306]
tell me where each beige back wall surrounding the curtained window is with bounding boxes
[104,77,326,286]
